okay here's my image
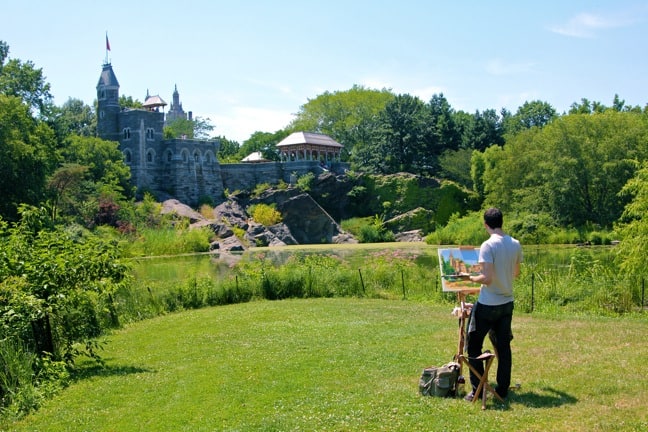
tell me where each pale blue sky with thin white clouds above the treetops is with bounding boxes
[5,0,648,143]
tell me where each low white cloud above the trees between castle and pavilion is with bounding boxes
[207,106,293,144]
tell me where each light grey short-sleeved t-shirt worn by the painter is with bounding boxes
[478,234,522,306]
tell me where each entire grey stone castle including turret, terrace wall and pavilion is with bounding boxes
[97,62,348,206]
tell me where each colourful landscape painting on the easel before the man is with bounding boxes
[439,246,481,293]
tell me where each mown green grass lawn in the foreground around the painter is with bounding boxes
[10,299,648,432]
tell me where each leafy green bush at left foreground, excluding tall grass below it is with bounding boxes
[0,208,128,363]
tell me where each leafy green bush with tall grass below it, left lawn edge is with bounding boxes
[0,206,129,417]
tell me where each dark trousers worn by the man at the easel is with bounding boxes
[466,302,513,397]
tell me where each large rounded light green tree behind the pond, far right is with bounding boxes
[475,110,648,229]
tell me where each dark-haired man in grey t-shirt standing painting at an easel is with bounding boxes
[466,208,522,400]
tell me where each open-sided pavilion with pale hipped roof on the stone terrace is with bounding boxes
[277,132,344,163]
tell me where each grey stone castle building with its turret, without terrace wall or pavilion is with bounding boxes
[97,62,223,205]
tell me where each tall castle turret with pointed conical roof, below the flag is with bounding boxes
[97,63,120,141]
